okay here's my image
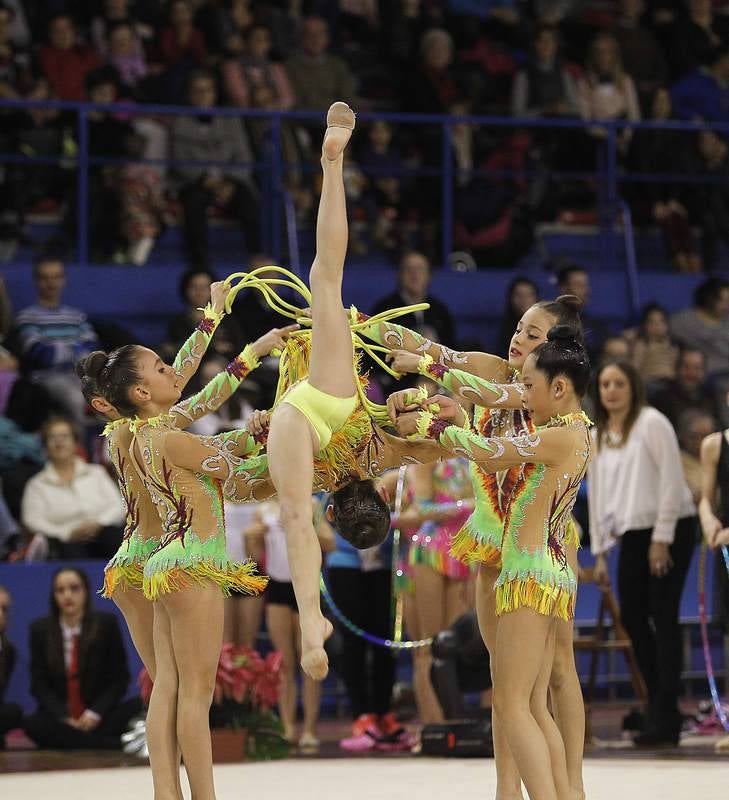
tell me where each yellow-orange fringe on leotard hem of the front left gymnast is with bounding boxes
[143,561,268,600]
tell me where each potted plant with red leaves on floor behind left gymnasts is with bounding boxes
[140,642,289,763]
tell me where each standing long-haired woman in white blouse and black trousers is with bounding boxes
[588,361,697,746]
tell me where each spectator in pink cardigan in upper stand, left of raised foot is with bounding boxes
[223,25,294,111]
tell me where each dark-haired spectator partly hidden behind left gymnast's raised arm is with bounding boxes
[167,268,243,368]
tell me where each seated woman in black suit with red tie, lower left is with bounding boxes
[24,567,141,750]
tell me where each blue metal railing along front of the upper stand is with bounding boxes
[0,100,729,288]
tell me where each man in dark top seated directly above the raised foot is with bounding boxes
[286,17,355,111]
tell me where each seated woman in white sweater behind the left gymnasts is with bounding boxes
[21,417,124,558]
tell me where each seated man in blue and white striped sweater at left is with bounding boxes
[16,255,98,425]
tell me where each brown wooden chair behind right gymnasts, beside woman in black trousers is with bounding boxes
[574,568,648,741]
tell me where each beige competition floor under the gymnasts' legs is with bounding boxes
[0,758,729,800]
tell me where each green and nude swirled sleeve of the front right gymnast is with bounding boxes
[415,411,574,472]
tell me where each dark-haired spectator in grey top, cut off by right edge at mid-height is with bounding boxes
[671,278,729,375]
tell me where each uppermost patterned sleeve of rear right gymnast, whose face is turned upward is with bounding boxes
[355,310,509,381]
